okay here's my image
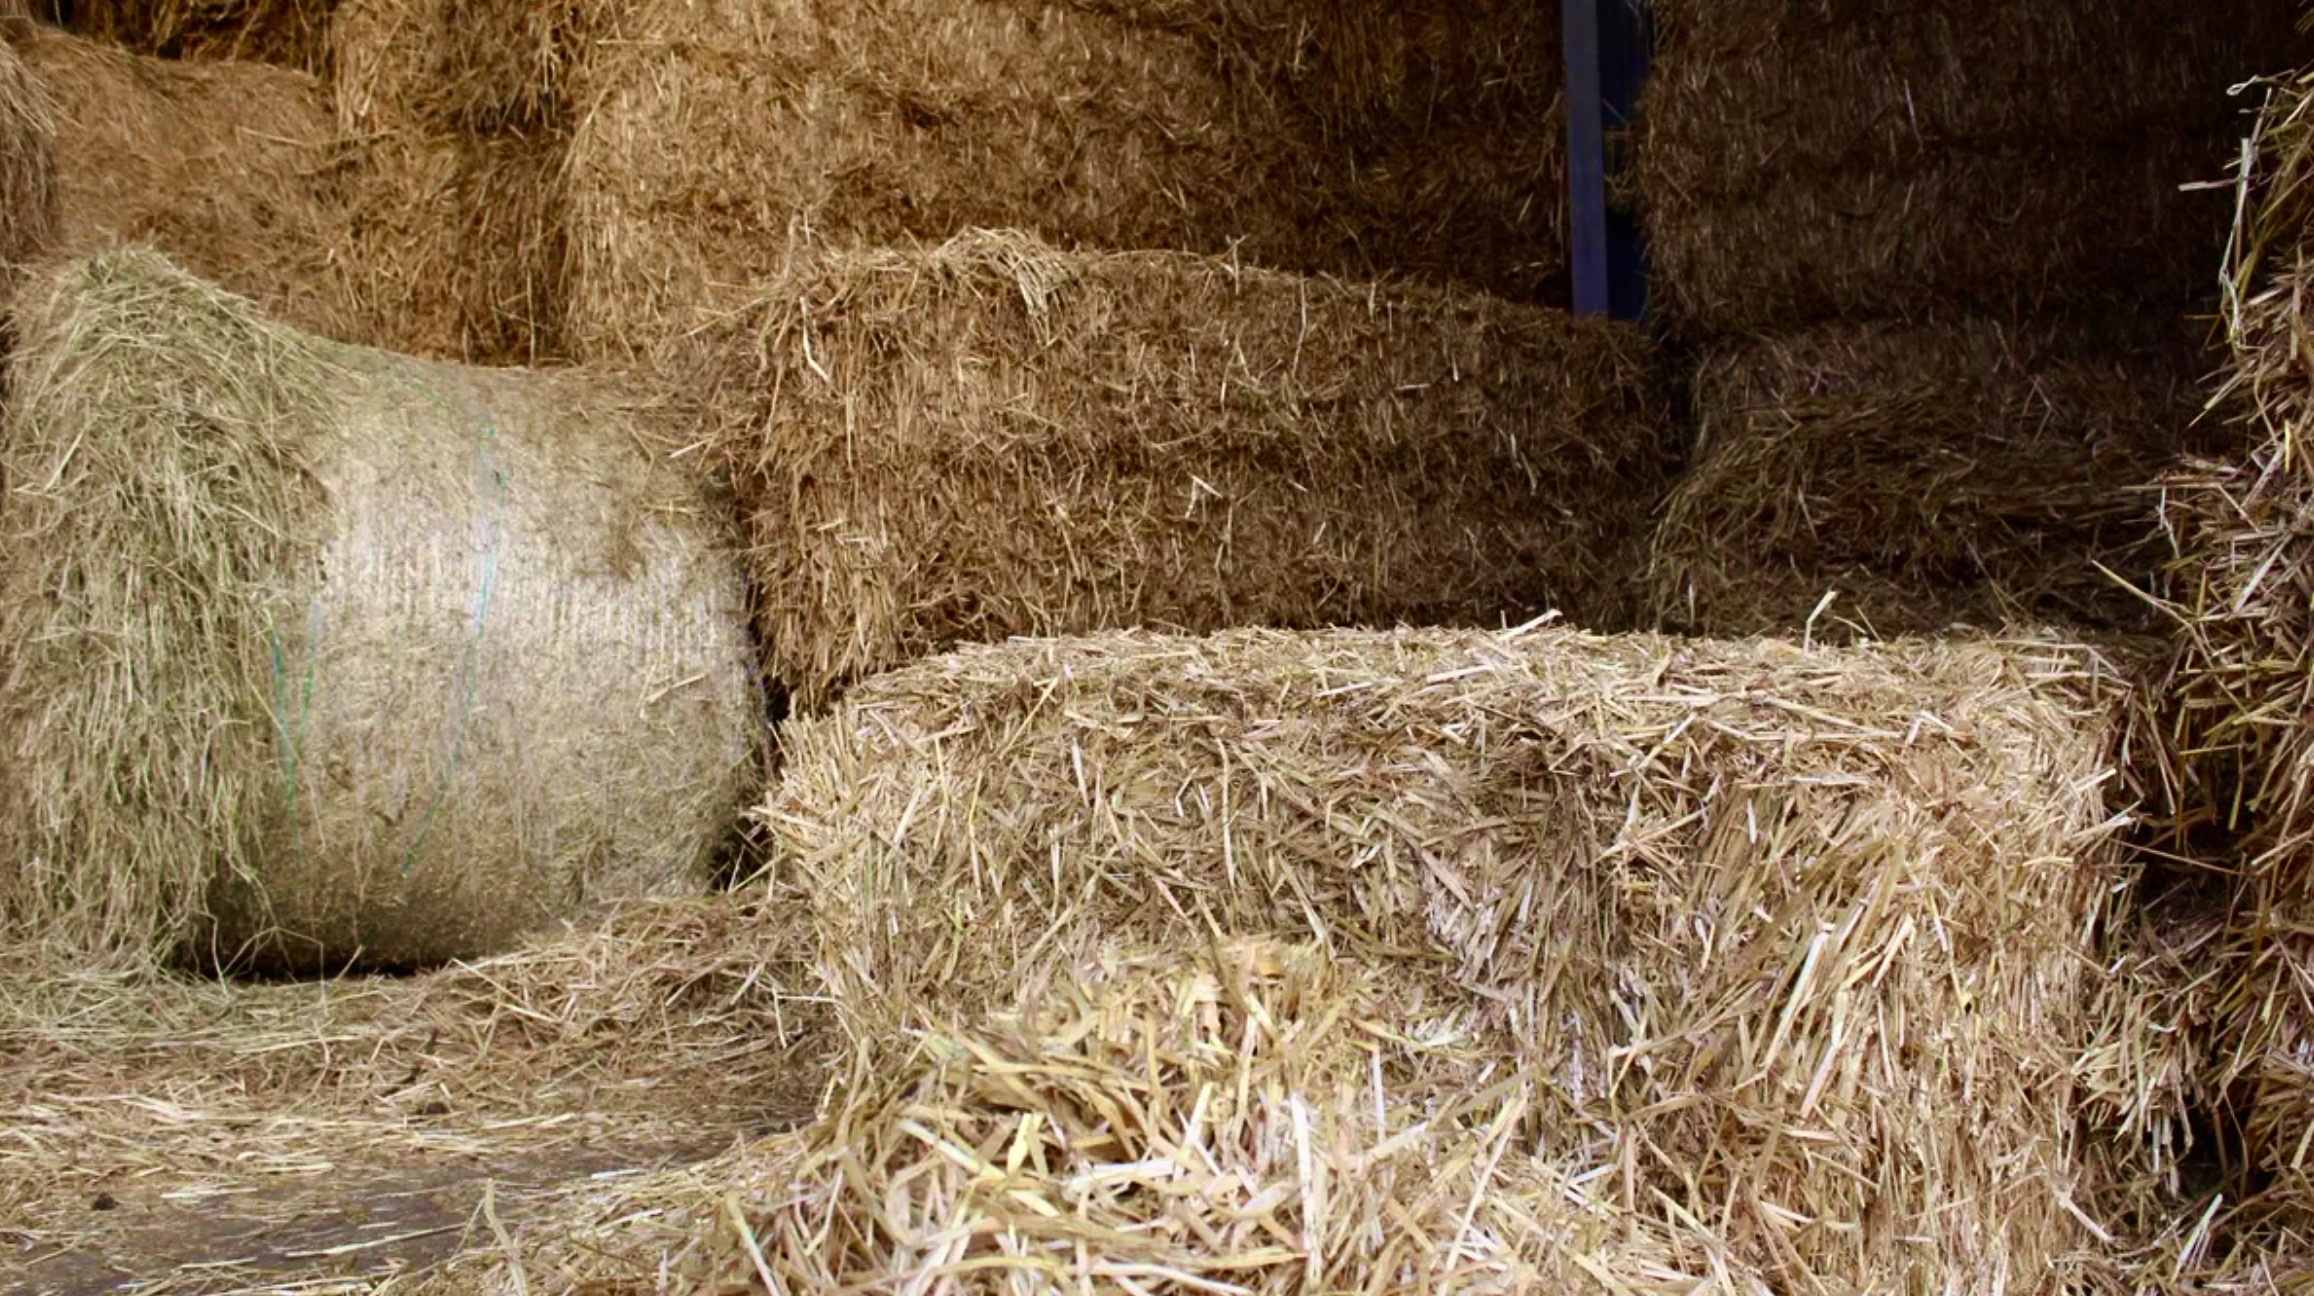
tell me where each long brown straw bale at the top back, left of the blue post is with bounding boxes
[569,0,1564,354]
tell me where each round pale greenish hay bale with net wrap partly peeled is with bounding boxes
[0,252,759,967]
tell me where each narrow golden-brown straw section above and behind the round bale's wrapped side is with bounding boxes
[331,0,569,363]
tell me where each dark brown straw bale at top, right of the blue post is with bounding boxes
[1634,0,2305,336]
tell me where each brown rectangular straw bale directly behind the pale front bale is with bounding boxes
[669,231,1666,706]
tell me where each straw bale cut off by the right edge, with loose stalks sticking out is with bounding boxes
[2161,76,2314,1231]
